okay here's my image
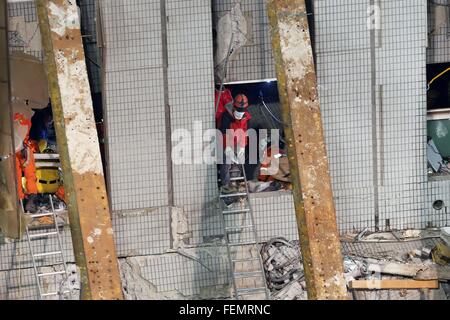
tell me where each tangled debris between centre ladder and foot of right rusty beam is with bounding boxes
[261,238,304,299]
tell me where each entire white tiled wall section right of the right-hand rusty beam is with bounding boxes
[314,0,448,232]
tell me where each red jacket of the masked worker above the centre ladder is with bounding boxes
[219,111,252,148]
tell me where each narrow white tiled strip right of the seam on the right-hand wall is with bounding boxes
[375,0,427,228]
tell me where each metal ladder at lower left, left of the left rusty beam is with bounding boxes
[22,194,70,299]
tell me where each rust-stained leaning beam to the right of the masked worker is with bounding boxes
[268,0,347,299]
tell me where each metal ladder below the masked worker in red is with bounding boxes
[219,164,269,300]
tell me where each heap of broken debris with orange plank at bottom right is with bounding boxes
[343,231,450,300]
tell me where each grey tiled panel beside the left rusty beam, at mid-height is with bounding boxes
[104,68,168,211]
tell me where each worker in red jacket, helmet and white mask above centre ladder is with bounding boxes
[219,94,251,193]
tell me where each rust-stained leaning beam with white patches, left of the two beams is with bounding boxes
[37,0,123,299]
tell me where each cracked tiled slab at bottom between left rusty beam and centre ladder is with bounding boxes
[119,250,231,300]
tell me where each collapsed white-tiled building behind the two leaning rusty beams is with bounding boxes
[0,0,450,299]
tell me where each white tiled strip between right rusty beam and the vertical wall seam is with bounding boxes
[313,0,377,232]
